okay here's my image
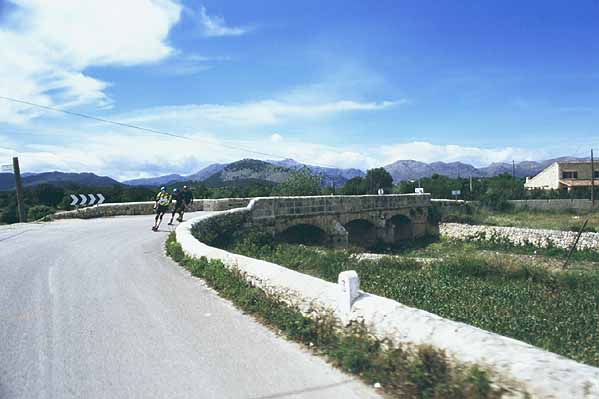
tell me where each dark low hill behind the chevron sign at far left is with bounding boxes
[0,172,122,191]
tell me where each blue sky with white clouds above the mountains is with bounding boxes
[0,0,599,180]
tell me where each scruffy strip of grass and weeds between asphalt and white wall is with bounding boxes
[166,234,505,399]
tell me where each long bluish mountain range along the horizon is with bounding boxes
[0,157,588,190]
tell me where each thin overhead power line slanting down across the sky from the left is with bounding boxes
[0,95,337,168]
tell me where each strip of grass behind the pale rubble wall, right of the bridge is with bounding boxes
[443,208,599,232]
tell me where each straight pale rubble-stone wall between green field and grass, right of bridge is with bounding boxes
[439,223,599,250]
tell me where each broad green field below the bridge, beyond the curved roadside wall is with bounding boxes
[227,234,599,366]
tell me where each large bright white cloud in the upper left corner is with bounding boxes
[0,0,181,124]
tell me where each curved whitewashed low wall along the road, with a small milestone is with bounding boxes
[176,208,599,399]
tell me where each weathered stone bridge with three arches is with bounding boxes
[246,194,438,246]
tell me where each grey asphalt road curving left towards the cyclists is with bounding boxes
[0,215,378,399]
